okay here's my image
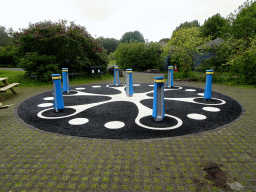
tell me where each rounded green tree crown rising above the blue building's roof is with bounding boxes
[201,13,228,39]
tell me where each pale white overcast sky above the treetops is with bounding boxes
[0,0,246,42]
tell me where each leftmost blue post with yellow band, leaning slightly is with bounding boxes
[52,74,64,112]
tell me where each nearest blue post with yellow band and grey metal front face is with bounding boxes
[152,77,165,121]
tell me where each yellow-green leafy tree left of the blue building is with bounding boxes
[163,27,212,77]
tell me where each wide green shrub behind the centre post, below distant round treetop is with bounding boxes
[116,41,164,71]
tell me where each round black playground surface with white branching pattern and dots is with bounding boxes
[18,83,242,139]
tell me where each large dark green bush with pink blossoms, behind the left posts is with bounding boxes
[16,20,108,81]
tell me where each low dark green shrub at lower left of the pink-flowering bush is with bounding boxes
[19,53,61,82]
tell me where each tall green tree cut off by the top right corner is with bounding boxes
[229,0,256,48]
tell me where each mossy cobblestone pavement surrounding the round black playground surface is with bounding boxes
[0,73,256,192]
